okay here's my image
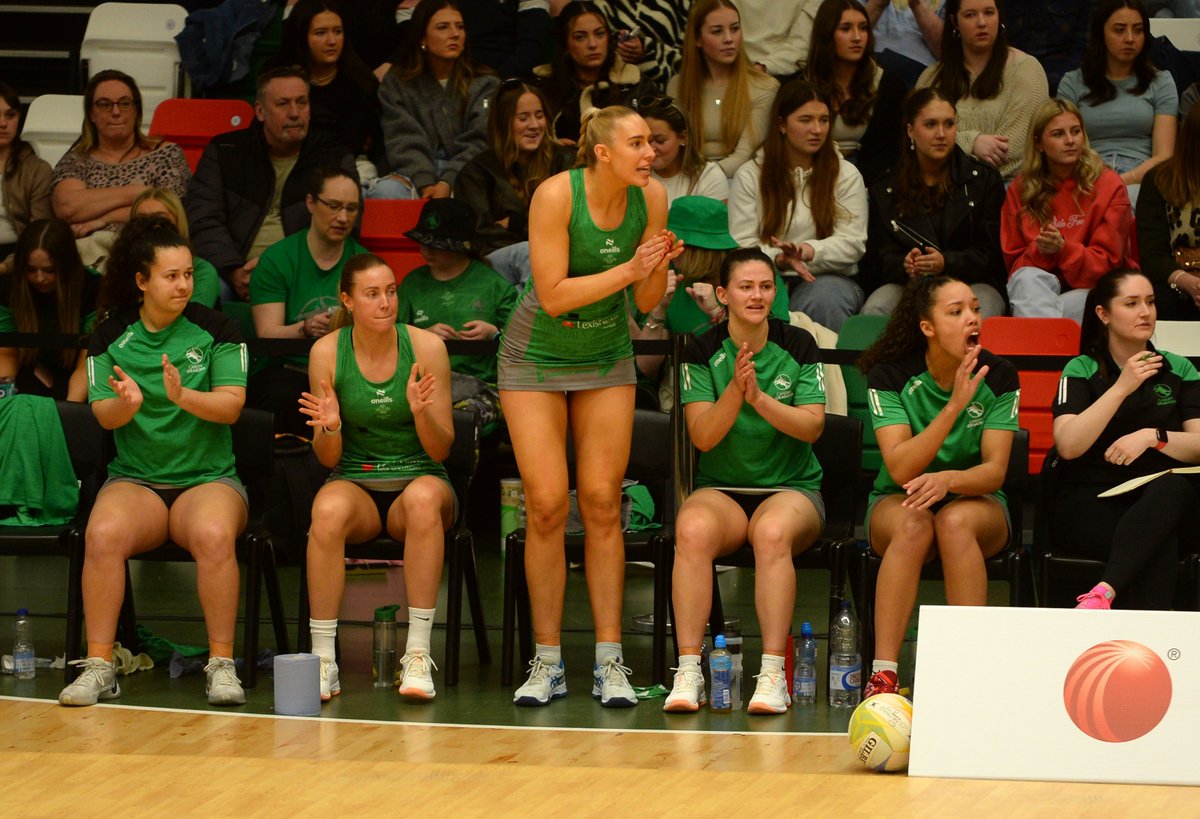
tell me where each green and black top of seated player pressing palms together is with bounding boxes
[679,318,826,491]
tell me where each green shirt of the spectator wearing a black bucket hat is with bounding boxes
[396,259,517,384]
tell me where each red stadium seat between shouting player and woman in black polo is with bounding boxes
[979,316,1079,474]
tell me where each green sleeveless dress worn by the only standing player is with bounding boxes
[500,168,647,372]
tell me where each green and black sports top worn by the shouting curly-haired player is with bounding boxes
[866,349,1021,503]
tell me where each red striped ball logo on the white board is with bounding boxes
[1062,640,1171,742]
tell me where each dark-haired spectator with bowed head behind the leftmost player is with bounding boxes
[0,219,100,401]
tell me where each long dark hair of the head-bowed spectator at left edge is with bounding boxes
[8,219,91,369]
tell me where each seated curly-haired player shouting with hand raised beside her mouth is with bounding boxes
[858,275,1020,699]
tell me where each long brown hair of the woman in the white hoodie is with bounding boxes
[758,79,841,245]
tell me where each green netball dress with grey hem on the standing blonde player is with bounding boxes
[499,168,646,391]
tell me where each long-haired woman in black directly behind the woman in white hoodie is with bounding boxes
[806,0,907,185]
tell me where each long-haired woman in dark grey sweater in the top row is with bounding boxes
[371,0,499,199]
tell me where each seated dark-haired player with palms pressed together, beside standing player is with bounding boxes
[662,247,826,713]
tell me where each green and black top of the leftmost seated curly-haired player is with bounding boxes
[88,301,247,486]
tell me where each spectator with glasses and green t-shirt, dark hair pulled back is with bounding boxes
[247,166,366,436]
